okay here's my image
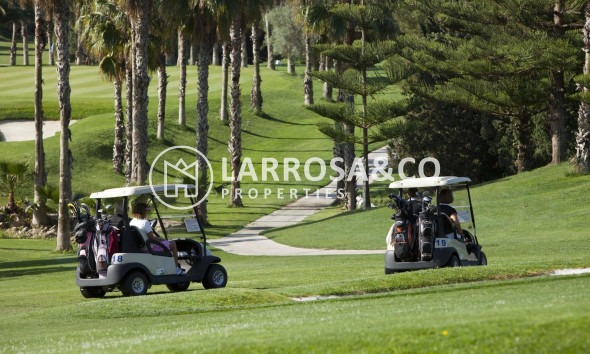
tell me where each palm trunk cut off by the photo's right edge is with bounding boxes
[574,0,590,173]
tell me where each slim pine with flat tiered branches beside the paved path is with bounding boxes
[309,4,403,209]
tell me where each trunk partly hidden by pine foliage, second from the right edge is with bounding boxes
[549,0,567,164]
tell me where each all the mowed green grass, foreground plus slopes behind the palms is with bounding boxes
[0,41,590,353]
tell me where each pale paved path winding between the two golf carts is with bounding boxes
[207,147,387,256]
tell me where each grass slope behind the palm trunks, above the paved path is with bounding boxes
[0,66,346,236]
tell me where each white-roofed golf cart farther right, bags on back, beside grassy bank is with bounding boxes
[385,176,487,274]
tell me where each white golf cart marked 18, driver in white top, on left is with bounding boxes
[75,184,227,298]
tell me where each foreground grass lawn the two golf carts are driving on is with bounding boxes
[0,239,590,352]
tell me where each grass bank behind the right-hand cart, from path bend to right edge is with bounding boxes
[265,164,590,267]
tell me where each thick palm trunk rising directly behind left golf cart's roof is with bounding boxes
[132,0,152,186]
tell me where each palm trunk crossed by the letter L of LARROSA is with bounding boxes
[228,18,243,207]
